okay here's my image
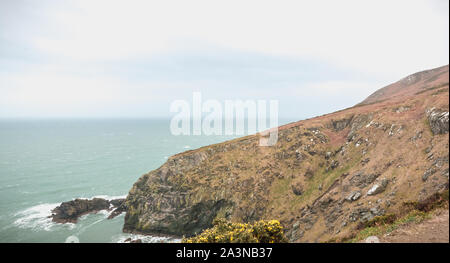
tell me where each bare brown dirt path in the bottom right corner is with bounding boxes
[380,210,449,243]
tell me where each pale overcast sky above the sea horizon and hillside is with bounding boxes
[0,0,449,120]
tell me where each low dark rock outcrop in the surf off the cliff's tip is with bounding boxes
[51,198,125,223]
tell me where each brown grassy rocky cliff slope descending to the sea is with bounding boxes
[124,66,449,242]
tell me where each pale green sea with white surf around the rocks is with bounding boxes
[0,119,246,242]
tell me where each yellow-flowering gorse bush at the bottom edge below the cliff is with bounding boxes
[181,219,287,243]
